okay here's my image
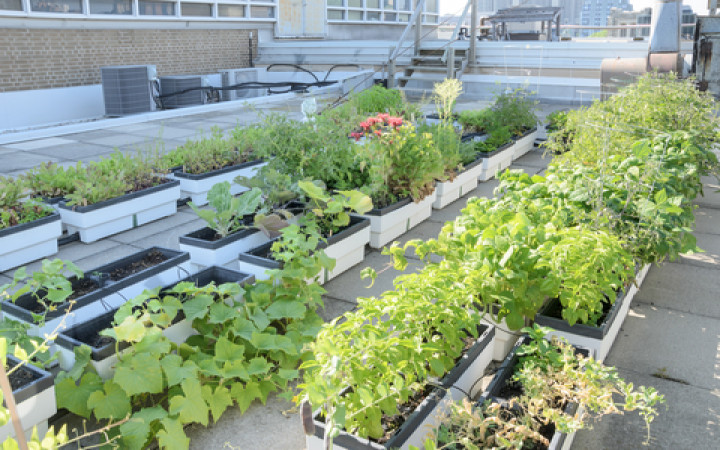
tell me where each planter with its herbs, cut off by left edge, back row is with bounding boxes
[0,177,62,271]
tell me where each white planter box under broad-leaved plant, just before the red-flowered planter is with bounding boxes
[238,216,370,284]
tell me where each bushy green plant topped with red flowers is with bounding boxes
[351,113,444,205]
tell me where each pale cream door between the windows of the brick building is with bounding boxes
[275,0,326,38]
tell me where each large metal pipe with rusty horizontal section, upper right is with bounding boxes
[600,0,683,100]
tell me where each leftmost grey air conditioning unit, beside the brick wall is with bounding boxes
[100,66,157,117]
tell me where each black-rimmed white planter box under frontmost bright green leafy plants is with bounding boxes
[305,325,495,450]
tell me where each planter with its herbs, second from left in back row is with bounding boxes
[59,152,180,242]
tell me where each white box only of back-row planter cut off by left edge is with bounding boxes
[0,213,62,272]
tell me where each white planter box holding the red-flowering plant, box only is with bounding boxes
[364,191,437,248]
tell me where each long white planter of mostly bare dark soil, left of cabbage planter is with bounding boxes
[2,247,190,336]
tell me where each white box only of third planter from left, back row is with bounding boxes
[170,160,266,206]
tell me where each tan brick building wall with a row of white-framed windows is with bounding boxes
[0,0,439,93]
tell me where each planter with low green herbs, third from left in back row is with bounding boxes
[163,126,263,206]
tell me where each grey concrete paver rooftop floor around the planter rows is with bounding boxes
[0,97,720,450]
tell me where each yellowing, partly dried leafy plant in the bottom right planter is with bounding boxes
[425,326,665,450]
